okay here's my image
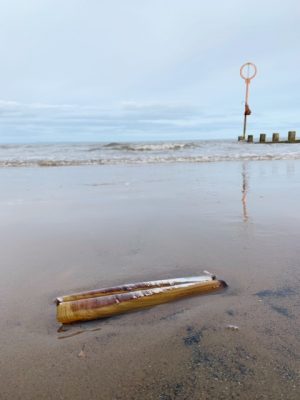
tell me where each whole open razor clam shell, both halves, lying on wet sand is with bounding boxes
[57,277,227,324]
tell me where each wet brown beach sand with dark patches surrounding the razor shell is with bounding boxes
[0,161,300,400]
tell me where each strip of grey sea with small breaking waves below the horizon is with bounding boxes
[0,140,300,168]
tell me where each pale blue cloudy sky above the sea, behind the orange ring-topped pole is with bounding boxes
[0,0,300,143]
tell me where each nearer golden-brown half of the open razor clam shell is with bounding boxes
[57,279,227,324]
